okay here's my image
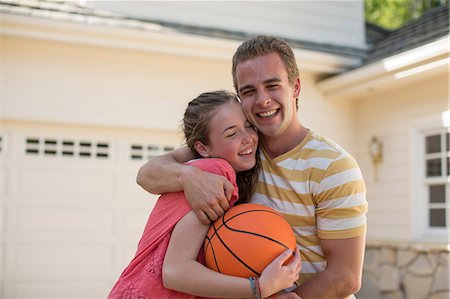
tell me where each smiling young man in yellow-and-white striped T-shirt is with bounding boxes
[138,36,367,299]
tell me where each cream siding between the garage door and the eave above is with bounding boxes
[3,37,232,131]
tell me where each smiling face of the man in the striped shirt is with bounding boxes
[236,53,300,138]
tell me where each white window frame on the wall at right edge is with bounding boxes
[411,112,450,242]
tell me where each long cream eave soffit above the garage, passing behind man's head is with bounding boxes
[0,14,359,73]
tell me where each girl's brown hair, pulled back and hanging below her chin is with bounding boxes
[182,90,261,203]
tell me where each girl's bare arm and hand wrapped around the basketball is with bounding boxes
[163,211,300,298]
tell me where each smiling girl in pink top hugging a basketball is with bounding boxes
[109,91,300,299]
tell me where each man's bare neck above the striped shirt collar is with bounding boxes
[261,123,309,159]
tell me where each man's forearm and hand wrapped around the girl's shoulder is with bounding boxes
[136,147,234,224]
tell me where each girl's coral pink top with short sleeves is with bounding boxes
[108,158,238,299]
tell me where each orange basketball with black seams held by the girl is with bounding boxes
[203,203,296,277]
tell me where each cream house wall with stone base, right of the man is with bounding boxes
[348,67,450,299]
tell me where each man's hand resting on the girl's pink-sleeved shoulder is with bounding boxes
[180,166,234,224]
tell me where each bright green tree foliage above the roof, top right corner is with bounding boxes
[364,0,450,30]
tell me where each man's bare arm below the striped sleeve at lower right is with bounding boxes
[295,236,366,299]
